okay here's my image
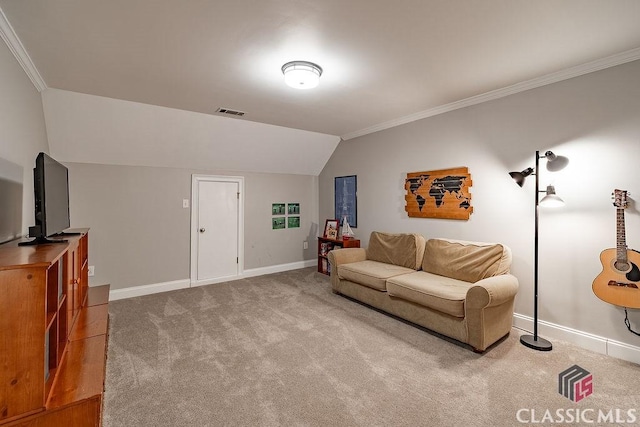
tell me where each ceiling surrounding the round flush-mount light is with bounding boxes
[0,0,640,173]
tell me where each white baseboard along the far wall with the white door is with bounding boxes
[109,259,317,301]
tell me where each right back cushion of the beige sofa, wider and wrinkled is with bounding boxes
[422,239,511,283]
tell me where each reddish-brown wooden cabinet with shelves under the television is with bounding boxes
[0,229,109,427]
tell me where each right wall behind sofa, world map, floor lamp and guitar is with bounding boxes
[319,61,640,354]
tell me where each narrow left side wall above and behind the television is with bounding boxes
[0,38,49,235]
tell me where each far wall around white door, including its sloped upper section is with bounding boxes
[37,89,324,290]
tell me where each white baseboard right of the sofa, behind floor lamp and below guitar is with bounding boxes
[513,313,640,365]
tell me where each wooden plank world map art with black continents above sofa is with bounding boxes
[404,167,473,220]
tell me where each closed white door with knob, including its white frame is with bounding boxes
[192,177,242,284]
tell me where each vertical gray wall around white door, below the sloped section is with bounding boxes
[65,163,318,289]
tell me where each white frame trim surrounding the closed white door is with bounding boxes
[190,174,244,287]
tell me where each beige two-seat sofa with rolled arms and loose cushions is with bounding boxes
[329,231,518,352]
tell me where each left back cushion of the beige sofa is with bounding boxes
[367,231,426,270]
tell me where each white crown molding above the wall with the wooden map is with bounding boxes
[341,48,640,140]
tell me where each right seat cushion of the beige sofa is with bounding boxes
[387,271,473,318]
